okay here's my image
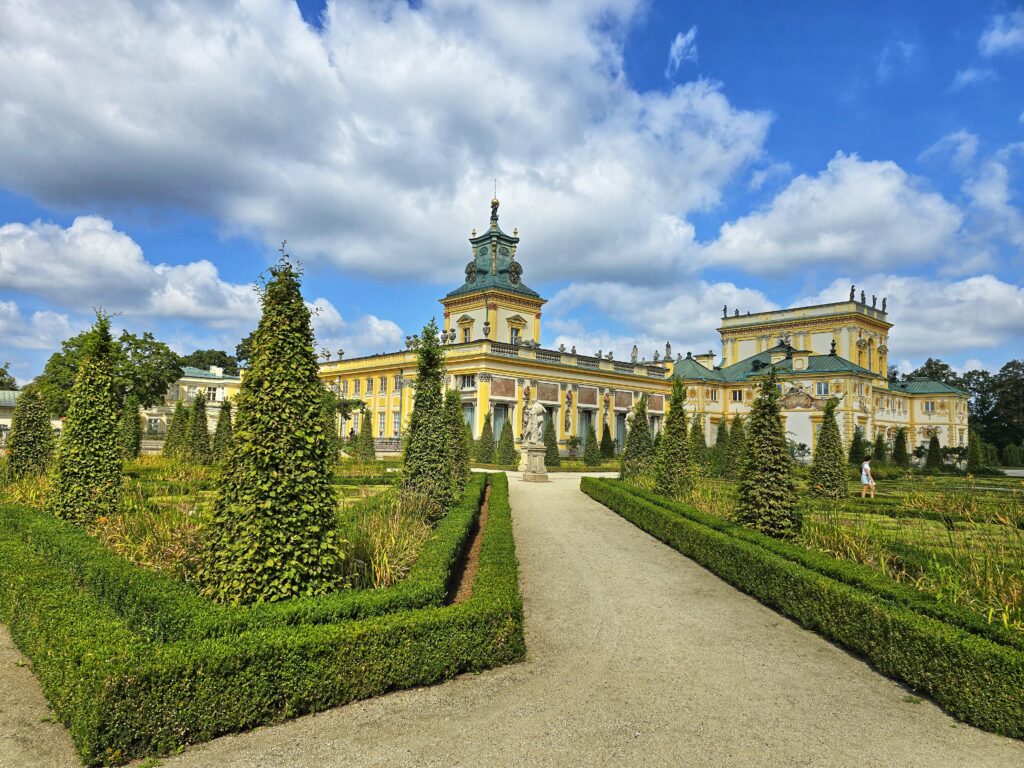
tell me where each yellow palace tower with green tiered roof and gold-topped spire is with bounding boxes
[440,198,546,344]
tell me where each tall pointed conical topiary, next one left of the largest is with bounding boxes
[48,313,124,522]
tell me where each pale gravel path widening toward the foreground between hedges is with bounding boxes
[0,474,1024,768]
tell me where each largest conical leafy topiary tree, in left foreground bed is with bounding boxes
[198,255,343,603]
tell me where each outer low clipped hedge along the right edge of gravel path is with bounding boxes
[581,477,1024,738]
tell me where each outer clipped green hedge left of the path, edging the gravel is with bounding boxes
[0,476,525,765]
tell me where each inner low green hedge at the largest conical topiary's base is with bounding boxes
[0,475,485,640]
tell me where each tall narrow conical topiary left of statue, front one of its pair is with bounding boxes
[403,318,457,511]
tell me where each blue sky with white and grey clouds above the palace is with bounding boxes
[0,0,1024,383]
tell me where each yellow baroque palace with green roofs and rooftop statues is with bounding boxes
[321,200,968,460]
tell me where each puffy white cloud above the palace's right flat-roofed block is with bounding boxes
[701,153,963,274]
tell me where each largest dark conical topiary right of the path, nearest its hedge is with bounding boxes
[736,368,801,539]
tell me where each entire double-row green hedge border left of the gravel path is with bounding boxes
[0,474,525,765]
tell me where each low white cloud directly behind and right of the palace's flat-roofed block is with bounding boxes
[793,273,1024,360]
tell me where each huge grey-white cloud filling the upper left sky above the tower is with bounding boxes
[0,0,771,282]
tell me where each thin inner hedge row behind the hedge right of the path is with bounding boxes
[616,481,1024,650]
